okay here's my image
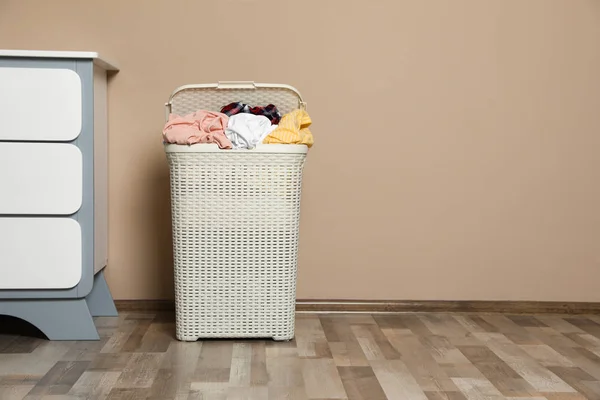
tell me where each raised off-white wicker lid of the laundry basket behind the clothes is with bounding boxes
[165,81,306,120]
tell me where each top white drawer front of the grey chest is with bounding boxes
[0,67,82,141]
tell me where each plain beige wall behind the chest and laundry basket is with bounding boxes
[0,0,600,301]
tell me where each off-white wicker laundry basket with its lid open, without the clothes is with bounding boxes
[165,82,307,341]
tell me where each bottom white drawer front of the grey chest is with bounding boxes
[0,218,82,289]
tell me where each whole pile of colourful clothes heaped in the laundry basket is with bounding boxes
[163,102,314,149]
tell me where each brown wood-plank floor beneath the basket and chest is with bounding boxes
[0,313,600,400]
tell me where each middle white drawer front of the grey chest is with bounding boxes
[0,142,83,215]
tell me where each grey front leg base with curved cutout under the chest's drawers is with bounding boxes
[0,299,100,340]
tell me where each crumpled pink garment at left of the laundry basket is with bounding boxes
[163,110,232,149]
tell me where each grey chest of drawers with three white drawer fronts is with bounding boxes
[0,50,117,340]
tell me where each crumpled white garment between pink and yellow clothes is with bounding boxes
[225,113,277,149]
